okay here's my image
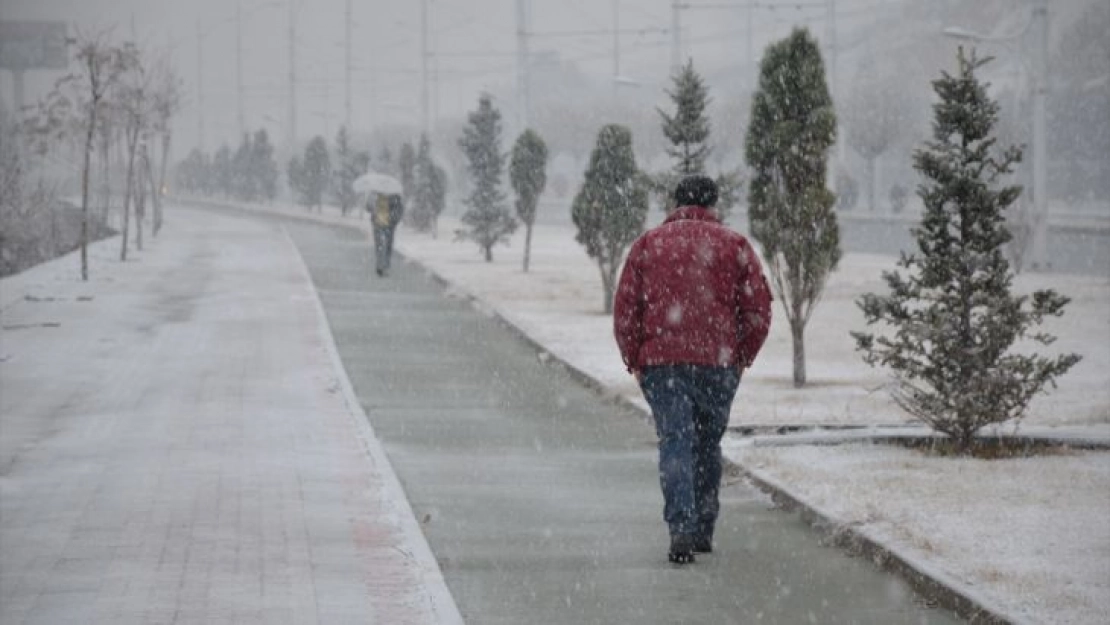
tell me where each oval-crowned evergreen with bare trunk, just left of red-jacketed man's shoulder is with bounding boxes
[571,124,648,313]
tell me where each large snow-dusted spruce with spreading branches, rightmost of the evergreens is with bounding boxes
[852,49,1079,452]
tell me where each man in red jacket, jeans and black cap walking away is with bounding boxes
[613,175,771,564]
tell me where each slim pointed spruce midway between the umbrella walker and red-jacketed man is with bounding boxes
[458,94,516,262]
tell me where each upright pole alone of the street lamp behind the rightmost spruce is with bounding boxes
[1031,0,1051,271]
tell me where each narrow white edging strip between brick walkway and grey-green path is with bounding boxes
[282,226,464,625]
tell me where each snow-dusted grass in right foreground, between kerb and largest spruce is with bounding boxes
[728,443,1110,624]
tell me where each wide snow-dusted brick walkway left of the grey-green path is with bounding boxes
[0,211,461,624]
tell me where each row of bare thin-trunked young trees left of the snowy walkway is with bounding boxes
[23,33,181,280]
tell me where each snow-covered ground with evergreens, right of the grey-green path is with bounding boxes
[168,202,1110,624]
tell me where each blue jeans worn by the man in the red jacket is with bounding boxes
[640,364,740,538]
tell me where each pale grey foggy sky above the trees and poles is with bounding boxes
[2,0,1091,160]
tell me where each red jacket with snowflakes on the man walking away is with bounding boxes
[613,206,771,372]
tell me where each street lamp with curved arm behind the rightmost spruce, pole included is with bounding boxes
[942,0,1051,270]
